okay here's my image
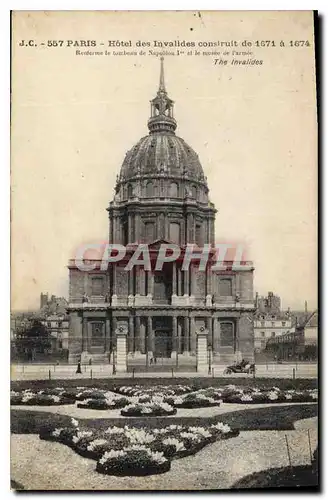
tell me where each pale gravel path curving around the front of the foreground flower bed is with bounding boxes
[11,416,317,491]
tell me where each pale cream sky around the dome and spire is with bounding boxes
[11,11,317,310]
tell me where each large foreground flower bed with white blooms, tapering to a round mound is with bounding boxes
[40,419,239,476]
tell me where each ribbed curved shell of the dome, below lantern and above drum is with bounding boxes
[120,131,206,183]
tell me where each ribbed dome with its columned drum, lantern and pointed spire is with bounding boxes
[107,58,216,246]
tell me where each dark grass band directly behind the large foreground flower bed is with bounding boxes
[11,403,317,434]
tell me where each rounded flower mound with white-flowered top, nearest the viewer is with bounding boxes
[96,445,171,476]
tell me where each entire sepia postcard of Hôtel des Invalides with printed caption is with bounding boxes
[10,11,319,491]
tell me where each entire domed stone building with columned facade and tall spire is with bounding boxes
[68,58,254,369]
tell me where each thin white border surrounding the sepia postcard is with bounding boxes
[0,0,322,498]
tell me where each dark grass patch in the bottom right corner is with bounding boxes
[231,465,319,489]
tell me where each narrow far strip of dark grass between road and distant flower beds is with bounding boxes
[11,377,318,391]
